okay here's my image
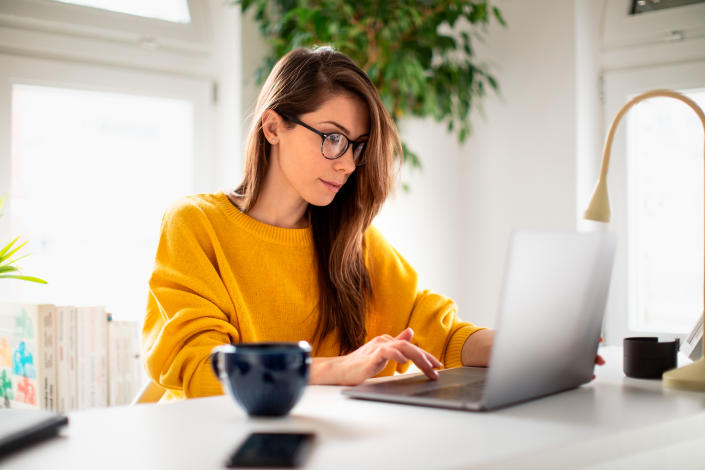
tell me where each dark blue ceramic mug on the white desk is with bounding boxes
[210,341,311,416]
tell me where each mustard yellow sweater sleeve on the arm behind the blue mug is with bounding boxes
[142,198,239,397]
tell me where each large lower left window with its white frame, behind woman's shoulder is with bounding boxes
[0,51,217,321]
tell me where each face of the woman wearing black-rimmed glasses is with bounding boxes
[270,93,369,206]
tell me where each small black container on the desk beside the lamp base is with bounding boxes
[623,337,680,379]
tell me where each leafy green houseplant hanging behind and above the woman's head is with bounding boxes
[232,0,506,172]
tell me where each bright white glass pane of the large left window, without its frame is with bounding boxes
[5,85,194,321]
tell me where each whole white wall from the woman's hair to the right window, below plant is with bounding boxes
[381,0,576,326]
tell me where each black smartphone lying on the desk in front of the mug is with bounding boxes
[225,432,314,468]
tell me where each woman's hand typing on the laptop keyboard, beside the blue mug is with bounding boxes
[310,328,443,385]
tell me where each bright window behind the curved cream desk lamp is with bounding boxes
[604,61,705,344]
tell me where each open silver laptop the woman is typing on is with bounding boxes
[343,232,616,410]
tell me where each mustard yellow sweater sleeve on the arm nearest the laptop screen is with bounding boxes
[365,227,482,373]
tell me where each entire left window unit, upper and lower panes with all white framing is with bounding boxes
[0,0,241,321]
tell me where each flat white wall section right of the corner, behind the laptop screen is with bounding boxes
[458,0,576,326]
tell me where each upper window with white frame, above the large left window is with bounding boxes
[0,0,213,52]
